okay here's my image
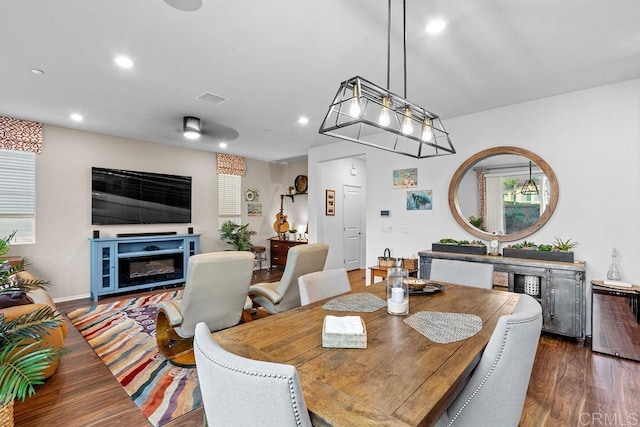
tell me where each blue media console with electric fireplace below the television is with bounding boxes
[89,234,200,301]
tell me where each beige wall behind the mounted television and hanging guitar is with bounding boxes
[9,125,306,300]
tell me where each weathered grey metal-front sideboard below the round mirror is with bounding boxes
[419,251,586,339]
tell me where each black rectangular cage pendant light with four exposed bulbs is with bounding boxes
[320,76,456,159]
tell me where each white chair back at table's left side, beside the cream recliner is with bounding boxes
[298,268,351,305]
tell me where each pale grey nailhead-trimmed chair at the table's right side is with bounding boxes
[436,294,542,427]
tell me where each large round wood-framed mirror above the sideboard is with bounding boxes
[449,147,559,242]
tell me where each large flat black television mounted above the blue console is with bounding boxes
[91,167,191,225]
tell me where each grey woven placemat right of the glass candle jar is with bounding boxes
[404,311,482,344]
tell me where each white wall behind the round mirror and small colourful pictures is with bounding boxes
[309,79,640,300]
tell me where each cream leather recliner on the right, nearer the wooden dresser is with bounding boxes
[249,243,329,314]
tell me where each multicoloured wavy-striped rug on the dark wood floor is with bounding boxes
[67,290,202,426]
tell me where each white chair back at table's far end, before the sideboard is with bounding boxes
[429,258,493,289]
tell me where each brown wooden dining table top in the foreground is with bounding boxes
[213,281,519,426]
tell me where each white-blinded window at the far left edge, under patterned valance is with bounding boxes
[0,150,36,244]
